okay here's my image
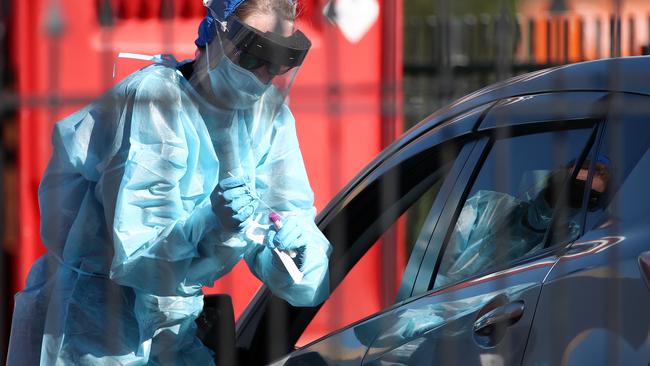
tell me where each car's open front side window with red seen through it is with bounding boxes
[296,149,454,347]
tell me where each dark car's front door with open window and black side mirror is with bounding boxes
[237,105,488,365]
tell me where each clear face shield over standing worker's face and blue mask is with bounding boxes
[199,8,311,110]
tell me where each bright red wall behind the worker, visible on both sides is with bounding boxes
[11,0,403,328]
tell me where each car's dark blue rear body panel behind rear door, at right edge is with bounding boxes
[524,94,650,365]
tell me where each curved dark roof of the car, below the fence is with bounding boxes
[319,56,650,222]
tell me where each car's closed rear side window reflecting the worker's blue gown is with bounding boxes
[434,128,593,288]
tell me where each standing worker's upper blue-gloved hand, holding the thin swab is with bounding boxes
[210,176,259,229]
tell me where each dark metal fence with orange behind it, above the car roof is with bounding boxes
[404,12,650,125]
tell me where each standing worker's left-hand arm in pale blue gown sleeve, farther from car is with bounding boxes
[103,76,218,295]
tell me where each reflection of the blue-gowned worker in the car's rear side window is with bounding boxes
[435,156,611,288]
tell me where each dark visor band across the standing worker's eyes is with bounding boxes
[226,16,311,75]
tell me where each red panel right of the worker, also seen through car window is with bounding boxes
[292,0,406,344]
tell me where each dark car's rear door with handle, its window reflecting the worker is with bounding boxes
[356,93,604,365]
